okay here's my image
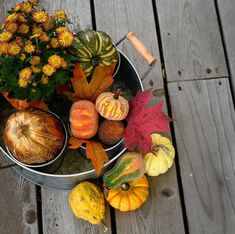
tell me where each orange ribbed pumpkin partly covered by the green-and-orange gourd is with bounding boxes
[105,176,149,211]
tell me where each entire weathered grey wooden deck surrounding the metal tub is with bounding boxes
[0,0,235,234]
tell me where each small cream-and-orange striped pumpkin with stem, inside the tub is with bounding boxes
[95,90,129,121]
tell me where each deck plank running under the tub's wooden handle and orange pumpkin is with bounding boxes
[95,0,184,233]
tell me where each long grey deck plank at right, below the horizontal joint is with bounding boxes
[168,78,235,234]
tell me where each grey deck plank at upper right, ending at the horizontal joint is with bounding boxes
[156,0,228,81]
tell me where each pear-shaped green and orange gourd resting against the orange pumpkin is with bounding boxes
[103,152,145,188]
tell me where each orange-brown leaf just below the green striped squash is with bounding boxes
[64,63,116,102]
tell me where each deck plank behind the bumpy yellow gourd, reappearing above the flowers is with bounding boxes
[38,0,111,234]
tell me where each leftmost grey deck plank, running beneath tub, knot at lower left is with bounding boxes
[0,0,38,234]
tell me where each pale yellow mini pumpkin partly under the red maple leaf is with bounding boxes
[144,133,175,176]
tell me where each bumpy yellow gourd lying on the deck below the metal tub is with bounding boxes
[68,181,105,224]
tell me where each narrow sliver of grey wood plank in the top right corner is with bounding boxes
[217,0,235,92]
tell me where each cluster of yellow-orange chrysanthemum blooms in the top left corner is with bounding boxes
[0,0,74,91]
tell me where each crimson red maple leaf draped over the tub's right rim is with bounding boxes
[122,89,171,153]
